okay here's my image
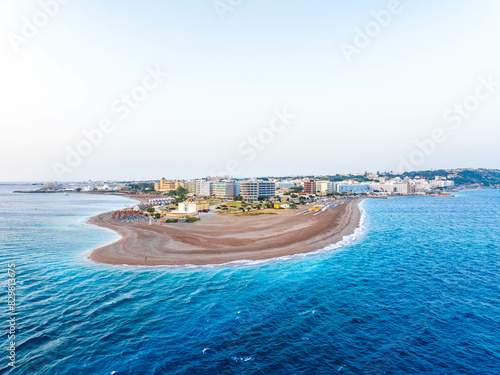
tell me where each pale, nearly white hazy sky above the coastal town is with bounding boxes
[0,0,500,181]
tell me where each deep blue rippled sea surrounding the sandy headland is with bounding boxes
[0,186,500,375]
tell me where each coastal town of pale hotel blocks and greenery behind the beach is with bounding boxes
[15,173,468,224]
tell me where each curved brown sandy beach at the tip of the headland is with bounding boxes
[89,198,362,266]
